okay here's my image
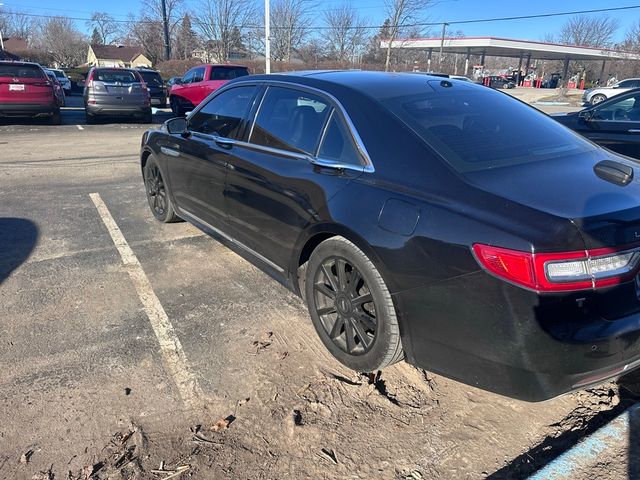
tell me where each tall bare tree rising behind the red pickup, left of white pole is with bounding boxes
[194,0,256,62]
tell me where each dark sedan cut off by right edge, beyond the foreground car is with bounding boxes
[552,89,640,159]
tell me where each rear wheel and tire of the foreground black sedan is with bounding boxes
[304,237,404,372]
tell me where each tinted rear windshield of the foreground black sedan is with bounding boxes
[383,82,596,173]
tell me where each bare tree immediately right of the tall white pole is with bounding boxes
[271,0,311,62]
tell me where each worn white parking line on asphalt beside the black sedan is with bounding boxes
[89,193,201,407]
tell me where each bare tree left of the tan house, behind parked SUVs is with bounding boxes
[33,17,88,66]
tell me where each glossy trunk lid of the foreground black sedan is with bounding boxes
[465,148,640,248]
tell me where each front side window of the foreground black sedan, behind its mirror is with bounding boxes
[189,86,257,138]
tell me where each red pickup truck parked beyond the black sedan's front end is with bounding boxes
[169,64,249,116]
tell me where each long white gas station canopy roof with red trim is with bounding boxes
[381,37,640,60]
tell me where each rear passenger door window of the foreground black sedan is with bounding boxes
[249,87,331,155]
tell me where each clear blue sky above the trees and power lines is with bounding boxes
[0,0,640,41]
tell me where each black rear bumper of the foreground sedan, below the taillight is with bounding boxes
[394,272,640,401]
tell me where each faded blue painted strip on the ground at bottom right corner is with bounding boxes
[529,403,640,480]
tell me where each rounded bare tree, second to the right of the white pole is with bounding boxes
[324,4,366,62]
